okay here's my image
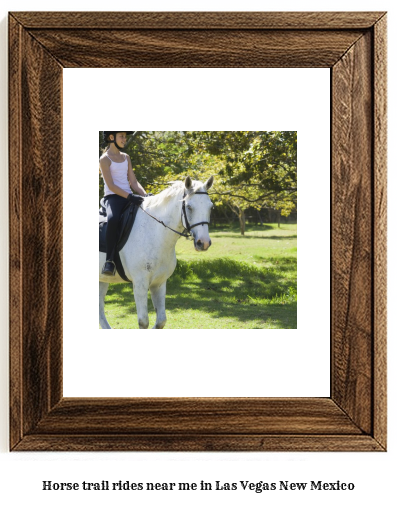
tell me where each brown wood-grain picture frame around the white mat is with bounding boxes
[9,12,386,451]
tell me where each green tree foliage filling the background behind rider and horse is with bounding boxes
[100,131,297,220]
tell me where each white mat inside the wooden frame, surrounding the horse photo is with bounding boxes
[63,69,330,397]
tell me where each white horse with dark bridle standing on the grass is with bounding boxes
[99,176,214,329]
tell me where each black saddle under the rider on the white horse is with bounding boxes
[99,199,139,283]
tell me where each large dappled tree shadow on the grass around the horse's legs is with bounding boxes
[108,258,297,329]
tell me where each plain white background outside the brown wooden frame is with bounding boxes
[0,0,397,506]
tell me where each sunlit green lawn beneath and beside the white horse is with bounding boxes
[106,224,297,329]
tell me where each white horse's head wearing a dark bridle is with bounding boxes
[183,176,214,252]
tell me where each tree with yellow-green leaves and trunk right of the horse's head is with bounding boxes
[181,131,297,234]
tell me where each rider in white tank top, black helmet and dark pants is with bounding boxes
[99,130,147,276]
